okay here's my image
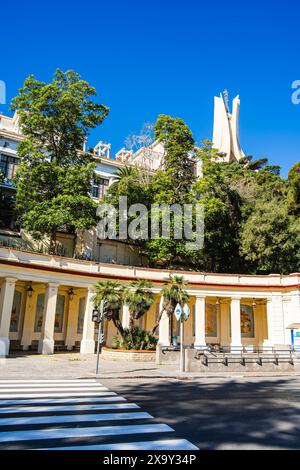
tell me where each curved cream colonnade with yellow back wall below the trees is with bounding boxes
[0,247,300,353]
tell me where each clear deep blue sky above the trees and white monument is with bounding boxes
[0,0,300,175]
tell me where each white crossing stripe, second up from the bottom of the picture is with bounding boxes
[0,424,174,442]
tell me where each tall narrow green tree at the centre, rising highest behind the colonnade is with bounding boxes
[142,114,197,267]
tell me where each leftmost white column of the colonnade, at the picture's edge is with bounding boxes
[0,277,17,357]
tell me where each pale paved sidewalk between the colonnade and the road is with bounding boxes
[0,353,300,380]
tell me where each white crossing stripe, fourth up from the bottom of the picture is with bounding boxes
[0,403,140,414]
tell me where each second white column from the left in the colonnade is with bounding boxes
[38,282,59,354]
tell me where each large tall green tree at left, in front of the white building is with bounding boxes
[12,70,108,253]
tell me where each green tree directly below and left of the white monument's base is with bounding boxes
[191,141,242,272]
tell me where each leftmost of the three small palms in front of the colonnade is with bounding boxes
[93,281,124,338]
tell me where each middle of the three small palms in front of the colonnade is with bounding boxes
[124,280,155,330]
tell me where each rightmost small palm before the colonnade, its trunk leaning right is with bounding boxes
[152,275,190,333]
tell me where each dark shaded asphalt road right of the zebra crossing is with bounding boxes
[101,377,300,450]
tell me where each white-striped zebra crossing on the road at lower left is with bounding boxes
[0,379,197,451]
